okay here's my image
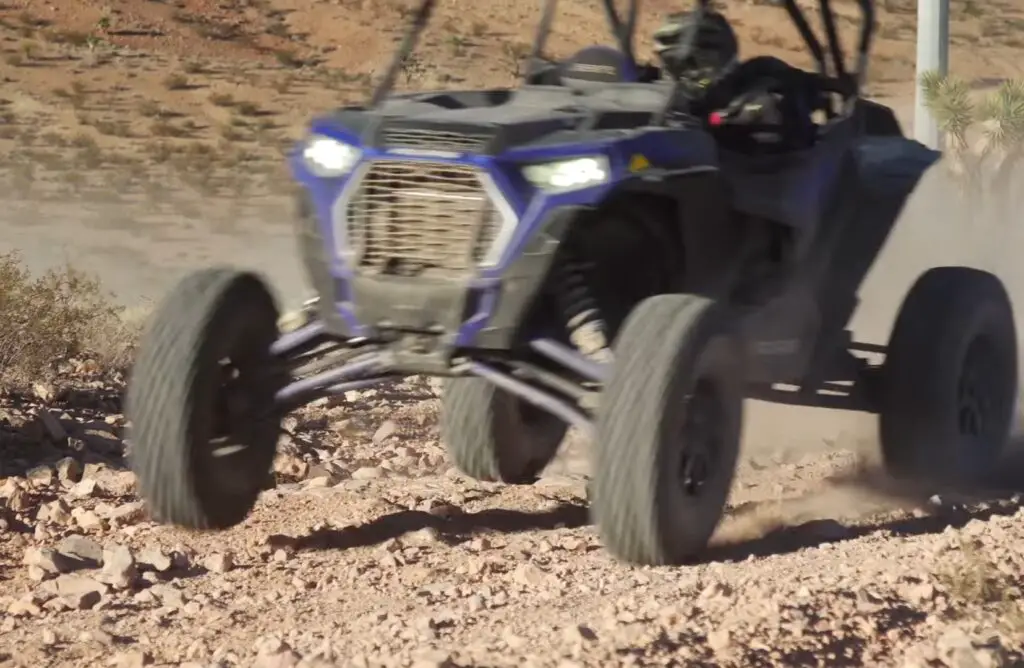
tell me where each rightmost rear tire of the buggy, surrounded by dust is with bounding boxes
[879,266,1018,484]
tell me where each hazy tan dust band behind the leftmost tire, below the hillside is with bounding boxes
[0,196,305,306]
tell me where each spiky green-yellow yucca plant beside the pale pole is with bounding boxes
[921,72,1024,216]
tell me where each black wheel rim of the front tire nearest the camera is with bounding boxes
[678,378,726,498]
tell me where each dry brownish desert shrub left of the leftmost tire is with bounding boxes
[0,252,141,389]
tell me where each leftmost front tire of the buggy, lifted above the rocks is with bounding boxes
[126,268,287,529]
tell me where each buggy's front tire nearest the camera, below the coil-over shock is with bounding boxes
[591,294,744,566]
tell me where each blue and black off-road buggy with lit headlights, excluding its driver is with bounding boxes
[128,0,1017,563]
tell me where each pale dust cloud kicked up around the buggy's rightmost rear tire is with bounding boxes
[737,141,1024,544]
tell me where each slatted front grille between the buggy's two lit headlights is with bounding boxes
[345,160,502,277]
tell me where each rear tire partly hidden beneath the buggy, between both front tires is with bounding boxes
[441,378,568,485]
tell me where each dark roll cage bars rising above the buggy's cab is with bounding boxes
[370,0,874,109]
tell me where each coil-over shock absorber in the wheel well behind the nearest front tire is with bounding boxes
[555,251,611,362]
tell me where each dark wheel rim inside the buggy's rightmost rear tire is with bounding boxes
[956,336,1006,456]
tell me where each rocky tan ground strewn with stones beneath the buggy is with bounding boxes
[0,374,1024,668]
